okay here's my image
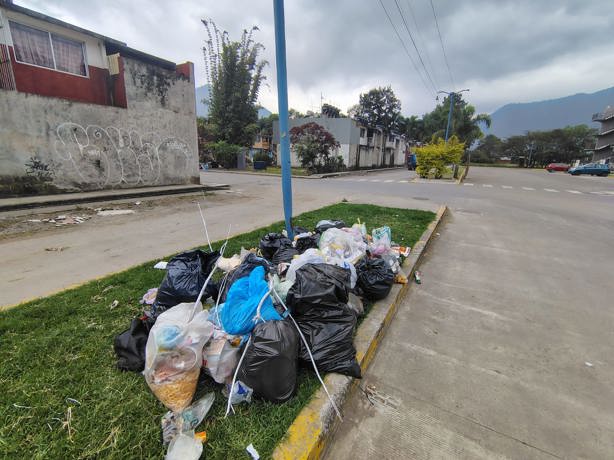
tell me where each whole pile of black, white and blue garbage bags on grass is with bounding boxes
[114,215,408,458]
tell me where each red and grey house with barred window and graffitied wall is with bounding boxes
[0,0,199,195]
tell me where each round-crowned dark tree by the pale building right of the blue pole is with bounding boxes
[355,86,401,165]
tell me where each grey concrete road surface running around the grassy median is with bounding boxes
[0,168,614,459]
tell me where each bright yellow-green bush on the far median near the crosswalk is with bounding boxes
[416,136,465,179]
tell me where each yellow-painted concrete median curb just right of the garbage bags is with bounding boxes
[273,206,448,460]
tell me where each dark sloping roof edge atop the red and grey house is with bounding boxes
[0,0,177,70]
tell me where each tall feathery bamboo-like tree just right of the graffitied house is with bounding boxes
[202,20,267,147]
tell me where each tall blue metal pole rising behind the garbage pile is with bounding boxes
[273,0,294,239]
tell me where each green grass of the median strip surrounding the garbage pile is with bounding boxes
[0,203,434,459]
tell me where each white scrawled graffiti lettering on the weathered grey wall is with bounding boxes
[55,122,197,188]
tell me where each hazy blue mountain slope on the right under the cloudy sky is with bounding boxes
[486,87,614,138]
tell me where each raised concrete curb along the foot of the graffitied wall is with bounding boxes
[0,184,230,212]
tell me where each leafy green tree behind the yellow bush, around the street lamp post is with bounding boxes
[422,94,491,147]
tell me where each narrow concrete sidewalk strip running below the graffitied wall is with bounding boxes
[0,183,228,212]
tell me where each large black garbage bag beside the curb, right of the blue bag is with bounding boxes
[286,264,361,378]
